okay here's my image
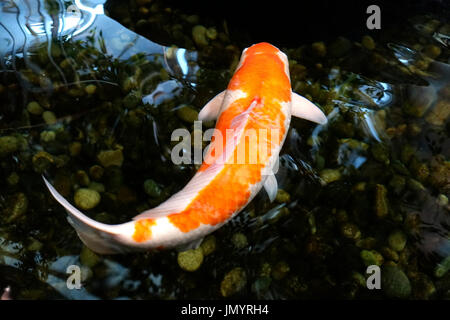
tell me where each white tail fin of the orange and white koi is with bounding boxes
[42,176,134,254]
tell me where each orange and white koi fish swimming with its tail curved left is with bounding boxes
[43,43,327,254]
